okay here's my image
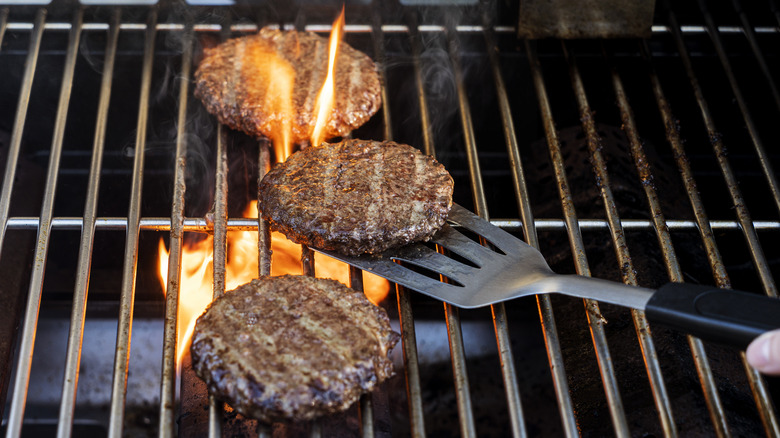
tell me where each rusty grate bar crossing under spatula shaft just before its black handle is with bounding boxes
[563,43,677,437]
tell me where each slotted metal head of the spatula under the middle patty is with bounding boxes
[320,204,554,308]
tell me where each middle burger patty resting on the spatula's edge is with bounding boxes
[259,140,453,255]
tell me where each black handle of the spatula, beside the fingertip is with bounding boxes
[645,283,780,349]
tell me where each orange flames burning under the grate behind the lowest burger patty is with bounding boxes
[158,201,390,366]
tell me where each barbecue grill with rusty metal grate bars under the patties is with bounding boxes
[0,0,780,437]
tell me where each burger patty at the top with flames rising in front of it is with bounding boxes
[195,28,382,143]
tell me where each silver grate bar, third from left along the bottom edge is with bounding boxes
[109,9,157,437]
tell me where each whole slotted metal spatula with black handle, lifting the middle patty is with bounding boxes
[321,204,780,347]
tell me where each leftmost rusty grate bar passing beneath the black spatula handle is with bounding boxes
[610,42,730,437]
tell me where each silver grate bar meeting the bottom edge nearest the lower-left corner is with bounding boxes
[6,10,81,437]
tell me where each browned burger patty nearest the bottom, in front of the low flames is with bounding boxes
[190,275,399,422]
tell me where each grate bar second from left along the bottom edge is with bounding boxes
[57,8,114,438]
